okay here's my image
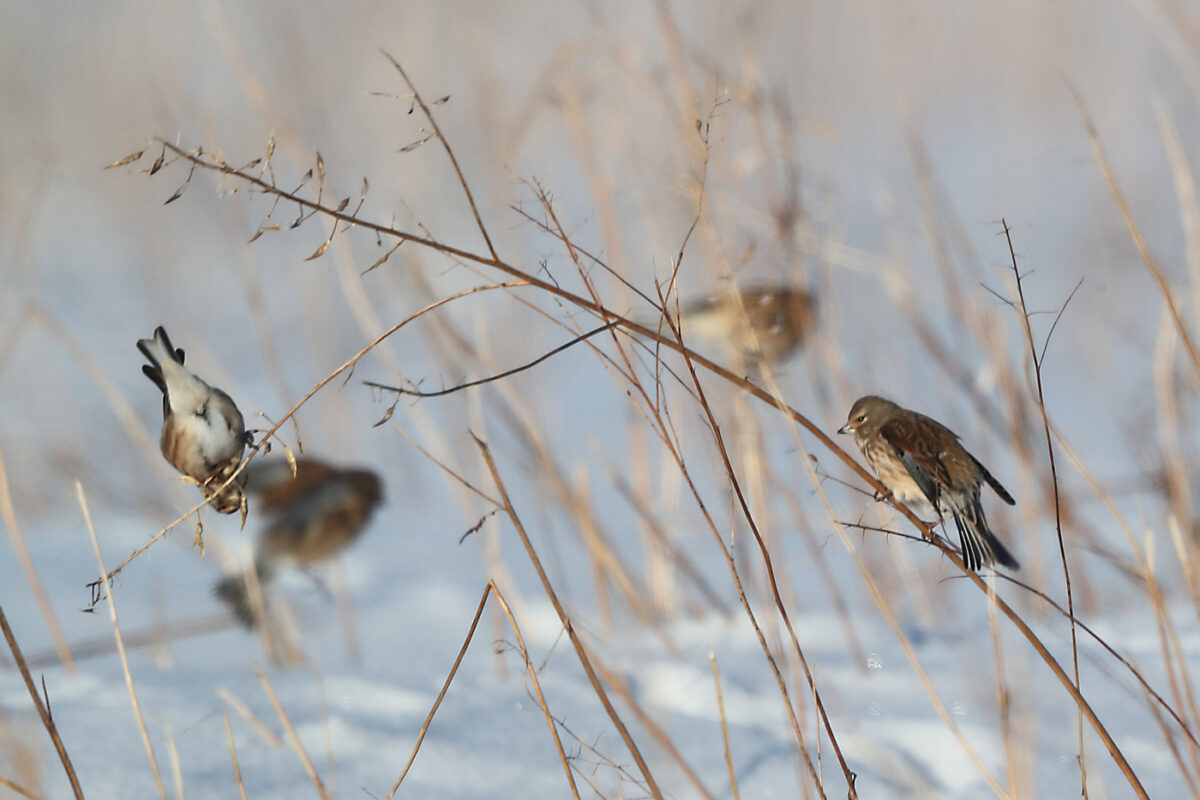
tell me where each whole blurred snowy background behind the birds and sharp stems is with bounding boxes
[0,0,1200,799]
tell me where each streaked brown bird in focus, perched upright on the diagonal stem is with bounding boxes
[838,395,1019,571]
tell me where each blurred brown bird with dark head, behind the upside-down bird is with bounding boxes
[215,458,383,626]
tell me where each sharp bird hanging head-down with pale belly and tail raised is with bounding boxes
[138,325,253,513]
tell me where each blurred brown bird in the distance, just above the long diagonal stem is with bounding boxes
[649,285,816,363]
